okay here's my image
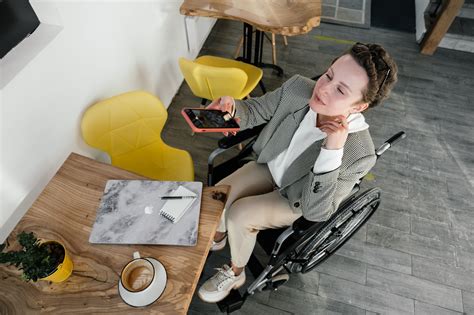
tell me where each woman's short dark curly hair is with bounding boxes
[333,43,398,108]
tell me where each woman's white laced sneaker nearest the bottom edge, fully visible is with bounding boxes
[198,265,245,303]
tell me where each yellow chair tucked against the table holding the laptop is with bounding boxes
[81,91,194,181]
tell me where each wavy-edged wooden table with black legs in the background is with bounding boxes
[180,0,321,80]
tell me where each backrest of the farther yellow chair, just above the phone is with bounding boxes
[179,58,248,100]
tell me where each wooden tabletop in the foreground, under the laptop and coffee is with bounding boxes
[0,153,229,314]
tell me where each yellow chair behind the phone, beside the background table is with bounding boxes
[179,56,263,105]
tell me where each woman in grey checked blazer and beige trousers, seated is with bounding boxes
[198,43,397,302]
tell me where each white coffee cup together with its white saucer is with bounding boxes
[119,252,166,306]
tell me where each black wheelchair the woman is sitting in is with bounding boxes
[207,125,406,313]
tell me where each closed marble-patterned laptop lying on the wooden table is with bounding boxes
[89,180,203,246]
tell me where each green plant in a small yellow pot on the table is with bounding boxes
[0,232,73,282]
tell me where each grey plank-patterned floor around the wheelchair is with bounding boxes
[164,20,474,314]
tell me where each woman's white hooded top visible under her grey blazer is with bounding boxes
[268,109,369,187]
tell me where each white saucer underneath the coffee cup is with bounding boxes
[119,257,167,307]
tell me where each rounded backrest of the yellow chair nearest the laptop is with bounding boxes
[81,91,168,160]
